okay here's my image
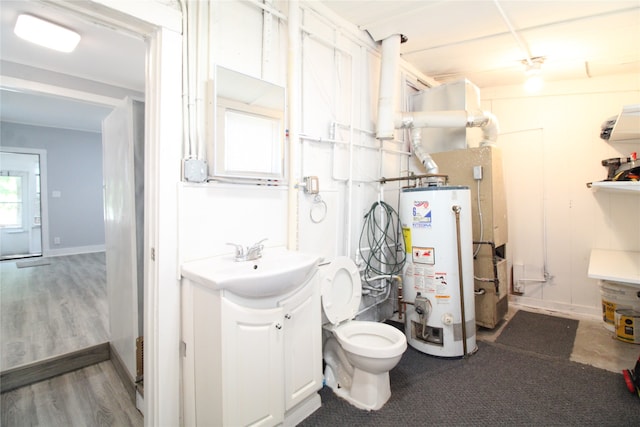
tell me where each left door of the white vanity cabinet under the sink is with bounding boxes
[221,298,284,426]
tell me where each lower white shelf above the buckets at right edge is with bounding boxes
[588,249,640,285]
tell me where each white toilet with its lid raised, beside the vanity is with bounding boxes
[319,257,407,410]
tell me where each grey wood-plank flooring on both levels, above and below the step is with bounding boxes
[0,252,143,427]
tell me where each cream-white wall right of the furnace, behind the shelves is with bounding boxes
[481,75,640,315]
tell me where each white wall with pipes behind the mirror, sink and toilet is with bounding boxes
[179,2,427,268]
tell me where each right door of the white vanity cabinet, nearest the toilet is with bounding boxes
[280,275,322,411]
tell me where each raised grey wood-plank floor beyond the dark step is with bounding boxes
[0,252,109,371]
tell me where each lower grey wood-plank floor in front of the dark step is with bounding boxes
[0,361,144,427]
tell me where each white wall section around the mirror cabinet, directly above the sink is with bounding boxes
[178,2,288,261]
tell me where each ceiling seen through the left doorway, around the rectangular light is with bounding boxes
[0,0,146,132]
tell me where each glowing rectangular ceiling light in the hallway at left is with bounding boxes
[13,15,80,53]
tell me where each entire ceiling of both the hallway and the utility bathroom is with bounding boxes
[0,0,640,131]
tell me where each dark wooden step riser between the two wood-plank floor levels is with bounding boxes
[0,343,111,393]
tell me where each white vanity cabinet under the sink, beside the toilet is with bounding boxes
[182,274,322,427]
